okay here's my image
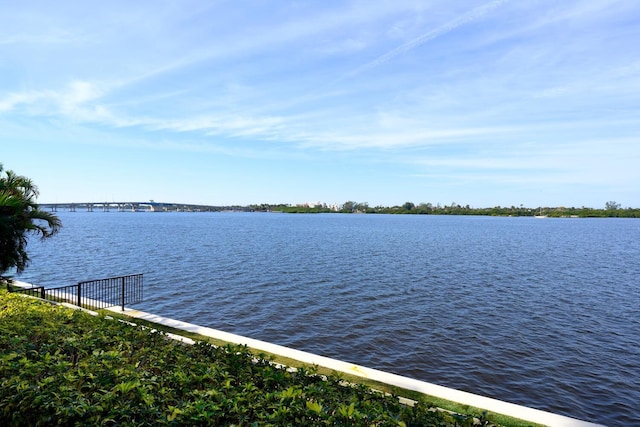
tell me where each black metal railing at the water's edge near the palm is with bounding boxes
[11,274,144,311]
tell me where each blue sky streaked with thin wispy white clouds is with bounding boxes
[0,0,640,208]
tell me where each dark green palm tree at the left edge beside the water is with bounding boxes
[0,163,61,275]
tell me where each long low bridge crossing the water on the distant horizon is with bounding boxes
[38,201,250,212]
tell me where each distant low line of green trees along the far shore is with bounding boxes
[250,200,640,218]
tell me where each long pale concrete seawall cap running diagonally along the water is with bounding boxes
[111,307,598,427]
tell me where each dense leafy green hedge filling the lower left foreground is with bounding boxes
[0,291,500,426]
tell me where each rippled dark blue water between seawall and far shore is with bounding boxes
[13,212,640,425]
